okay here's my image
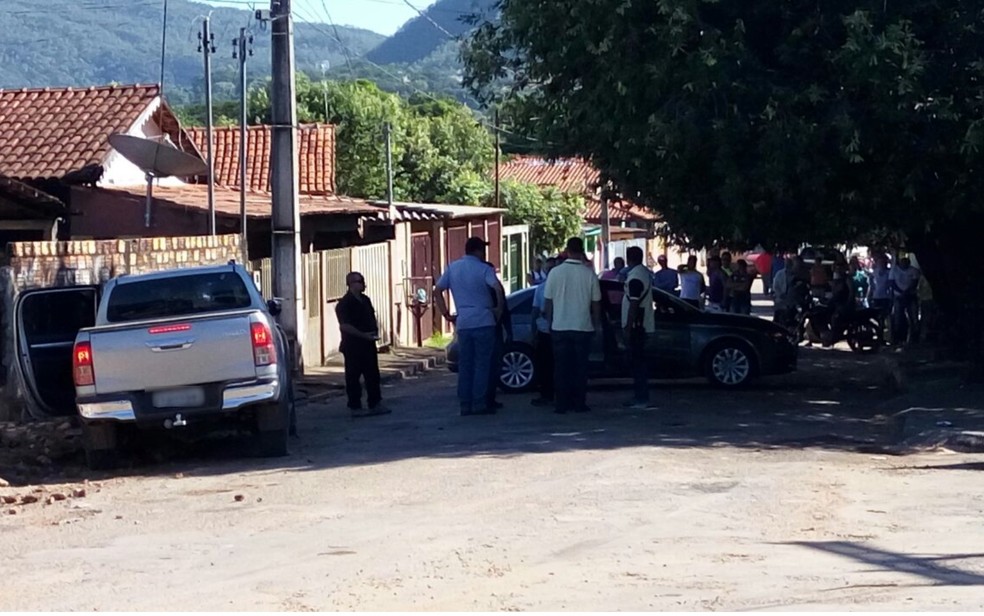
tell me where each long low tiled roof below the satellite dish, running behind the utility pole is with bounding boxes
[88,184,378,219]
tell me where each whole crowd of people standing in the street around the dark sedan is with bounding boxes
[336,237,932,416]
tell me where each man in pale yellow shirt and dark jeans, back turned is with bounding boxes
[543,237,601,413]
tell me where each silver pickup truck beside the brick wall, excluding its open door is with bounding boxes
[72,263,294,468]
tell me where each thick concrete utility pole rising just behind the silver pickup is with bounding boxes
[270,0,304,370]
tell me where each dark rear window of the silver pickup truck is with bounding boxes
[106,272,252,323]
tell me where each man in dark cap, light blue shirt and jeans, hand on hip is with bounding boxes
[434,237,506,415]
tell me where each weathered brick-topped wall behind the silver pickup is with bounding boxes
[0,235,240,421]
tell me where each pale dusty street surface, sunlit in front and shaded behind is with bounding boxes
[0,351,984,610]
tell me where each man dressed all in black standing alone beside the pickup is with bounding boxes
[335,272,390,417]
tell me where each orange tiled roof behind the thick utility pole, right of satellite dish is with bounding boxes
[187,124,335,195]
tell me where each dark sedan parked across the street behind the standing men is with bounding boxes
[447,280,797,392]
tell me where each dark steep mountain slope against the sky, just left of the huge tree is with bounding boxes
[366,0,495,68]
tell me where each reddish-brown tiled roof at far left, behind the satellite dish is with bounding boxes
[0,85,168,179]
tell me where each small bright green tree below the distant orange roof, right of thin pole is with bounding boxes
[492,180,584,253]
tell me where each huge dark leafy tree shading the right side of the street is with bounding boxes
[463,0,984,360]
